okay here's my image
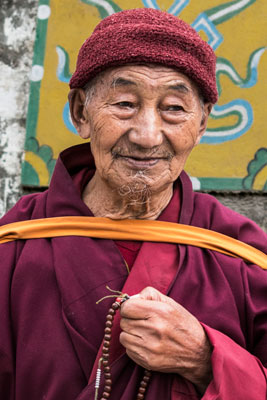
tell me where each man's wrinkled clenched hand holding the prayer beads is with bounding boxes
[120,287,212,393]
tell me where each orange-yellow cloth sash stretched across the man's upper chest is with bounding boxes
[0,217,267,269]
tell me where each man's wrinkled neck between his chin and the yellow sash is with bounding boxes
[82,175,173,219]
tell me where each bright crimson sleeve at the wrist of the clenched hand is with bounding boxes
[202,324,267,400]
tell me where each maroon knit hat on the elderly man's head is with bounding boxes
[70,8,218,103]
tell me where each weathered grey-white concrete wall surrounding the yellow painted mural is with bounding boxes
[0,0,267,232]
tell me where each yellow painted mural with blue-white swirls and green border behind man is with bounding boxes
[22,0,267,192]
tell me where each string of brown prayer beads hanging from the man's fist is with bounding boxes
[95,288,151,400]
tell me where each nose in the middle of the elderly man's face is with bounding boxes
[129,108,163,148]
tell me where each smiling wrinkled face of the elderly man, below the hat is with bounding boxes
[75,65,210,193]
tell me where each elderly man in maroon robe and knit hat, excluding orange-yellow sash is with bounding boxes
[0,9,267,400]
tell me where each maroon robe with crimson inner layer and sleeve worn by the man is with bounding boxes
[0,144,267,400]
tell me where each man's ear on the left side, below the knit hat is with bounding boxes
[68,89,91,139]
